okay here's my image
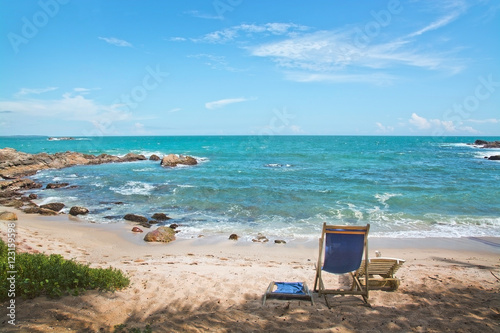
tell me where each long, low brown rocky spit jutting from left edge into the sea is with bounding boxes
[0,148,146,179]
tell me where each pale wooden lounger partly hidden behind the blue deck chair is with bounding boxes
[353,258,405,290]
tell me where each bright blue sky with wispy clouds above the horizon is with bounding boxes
[0,0,500,136]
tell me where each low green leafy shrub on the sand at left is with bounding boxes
[0,240,130,301]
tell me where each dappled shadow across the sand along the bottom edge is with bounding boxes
[0,280,500,333]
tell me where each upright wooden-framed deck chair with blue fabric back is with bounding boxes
[314,223,370,308]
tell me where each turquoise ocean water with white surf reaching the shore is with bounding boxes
[0,136,500,240]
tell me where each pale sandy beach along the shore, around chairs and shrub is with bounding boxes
[0,207,500,332]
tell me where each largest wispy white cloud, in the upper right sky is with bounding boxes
[249,30,463,80]
